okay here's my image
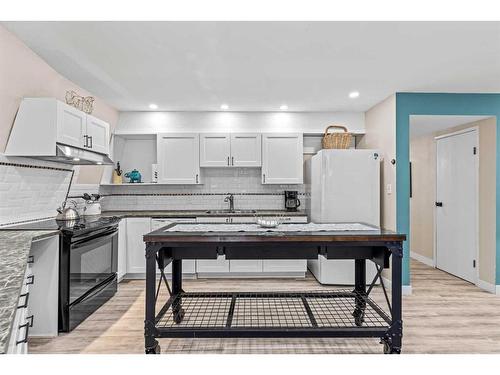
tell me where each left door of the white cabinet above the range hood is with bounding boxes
[57,102,87,148]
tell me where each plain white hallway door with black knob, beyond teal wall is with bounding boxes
[436,130,478,282]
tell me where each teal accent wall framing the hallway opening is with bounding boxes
[396,93,500,285]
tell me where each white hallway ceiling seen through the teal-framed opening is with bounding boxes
[410,115,491,138]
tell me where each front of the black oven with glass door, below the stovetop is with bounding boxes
[59,224,118,332]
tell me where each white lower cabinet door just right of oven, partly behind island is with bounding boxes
[127,217,151,273]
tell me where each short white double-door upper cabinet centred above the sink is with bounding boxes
[200,133,262,167]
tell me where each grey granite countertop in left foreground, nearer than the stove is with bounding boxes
[0,231,59,353]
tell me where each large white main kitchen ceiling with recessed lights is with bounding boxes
[3,22,500,111]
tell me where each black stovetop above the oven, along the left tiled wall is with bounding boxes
[0,216,120,234]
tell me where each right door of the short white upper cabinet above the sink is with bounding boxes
[231,133,262,167]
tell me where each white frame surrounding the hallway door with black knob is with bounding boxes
[433,126,480,286]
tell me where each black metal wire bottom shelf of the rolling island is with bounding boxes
[155,290,391,337]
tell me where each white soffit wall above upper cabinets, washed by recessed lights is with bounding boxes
[116,112,365,134]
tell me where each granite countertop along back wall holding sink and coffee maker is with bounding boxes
[101,210,307,218]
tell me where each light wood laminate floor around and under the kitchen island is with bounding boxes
[29,260,500,354]
